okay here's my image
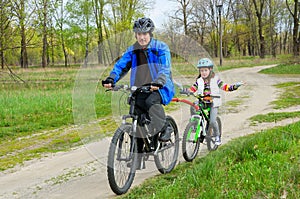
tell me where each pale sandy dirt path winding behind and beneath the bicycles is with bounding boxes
[0,66,300,199]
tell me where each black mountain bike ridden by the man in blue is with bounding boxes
[107,84,179,195]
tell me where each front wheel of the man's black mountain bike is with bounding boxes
[107,124,137,195]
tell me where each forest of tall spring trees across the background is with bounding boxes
[0,0,300,69]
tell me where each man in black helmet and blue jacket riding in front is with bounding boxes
[102,17,175,148]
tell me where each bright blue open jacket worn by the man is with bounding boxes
[110,38,175,105]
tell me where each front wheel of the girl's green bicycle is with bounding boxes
[182,120,203,162]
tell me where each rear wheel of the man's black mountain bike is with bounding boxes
[154,116,179,174]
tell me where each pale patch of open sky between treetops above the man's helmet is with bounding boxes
[149,0,178,29]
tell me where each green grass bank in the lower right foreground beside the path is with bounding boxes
[120,122,300,199]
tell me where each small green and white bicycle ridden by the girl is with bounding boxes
[173,92,222,162]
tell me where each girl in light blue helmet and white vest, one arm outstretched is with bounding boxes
[190,58,243,145]
